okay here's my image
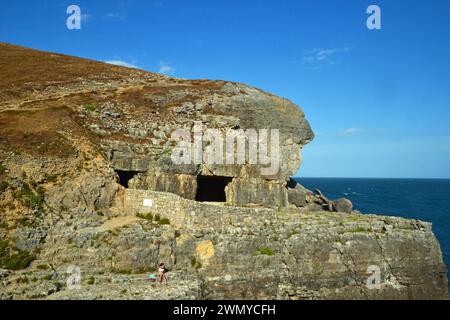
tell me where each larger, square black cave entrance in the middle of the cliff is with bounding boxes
[195,176,232,202]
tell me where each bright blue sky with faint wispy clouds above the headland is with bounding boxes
[0,0,450,178]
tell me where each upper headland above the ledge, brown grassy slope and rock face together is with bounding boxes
[0,45,313,207]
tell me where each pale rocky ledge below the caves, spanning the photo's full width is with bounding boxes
[1,191,447,299]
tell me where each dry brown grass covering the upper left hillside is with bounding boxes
[0,43,236,157]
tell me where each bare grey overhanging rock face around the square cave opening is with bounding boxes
[105,79,313,207]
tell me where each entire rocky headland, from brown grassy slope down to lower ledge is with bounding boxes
[0,44,447,299]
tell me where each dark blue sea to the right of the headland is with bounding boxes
[294,178,450,291]
